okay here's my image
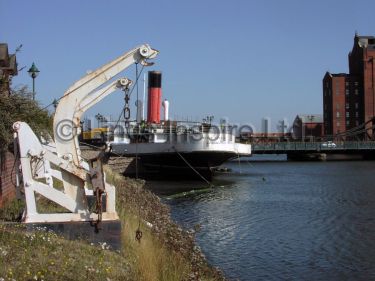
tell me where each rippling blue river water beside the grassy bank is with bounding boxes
[148,156,375,280]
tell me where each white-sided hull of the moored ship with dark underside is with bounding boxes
[109,129,251,177]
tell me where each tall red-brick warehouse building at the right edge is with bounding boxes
[323,34,375,138]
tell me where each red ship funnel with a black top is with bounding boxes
[147,71,161,123]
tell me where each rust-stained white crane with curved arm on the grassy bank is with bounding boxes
[13,44,158,223]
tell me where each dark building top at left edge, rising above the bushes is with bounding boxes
[0,43,17,95]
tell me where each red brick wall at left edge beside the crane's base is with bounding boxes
[0,152,16,207]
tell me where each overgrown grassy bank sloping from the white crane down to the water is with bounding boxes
[0,169,224,280]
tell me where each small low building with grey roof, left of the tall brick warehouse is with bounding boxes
[293,114,323,141]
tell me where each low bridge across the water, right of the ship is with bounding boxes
[251,141,375,158]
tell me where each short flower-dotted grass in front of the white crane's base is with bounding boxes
[0,224,134,280]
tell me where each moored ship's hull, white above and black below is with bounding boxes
[110,133,251,180]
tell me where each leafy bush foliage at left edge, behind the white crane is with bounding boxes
[0,87,52,153]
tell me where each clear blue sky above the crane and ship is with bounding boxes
[0,0,375,129]
